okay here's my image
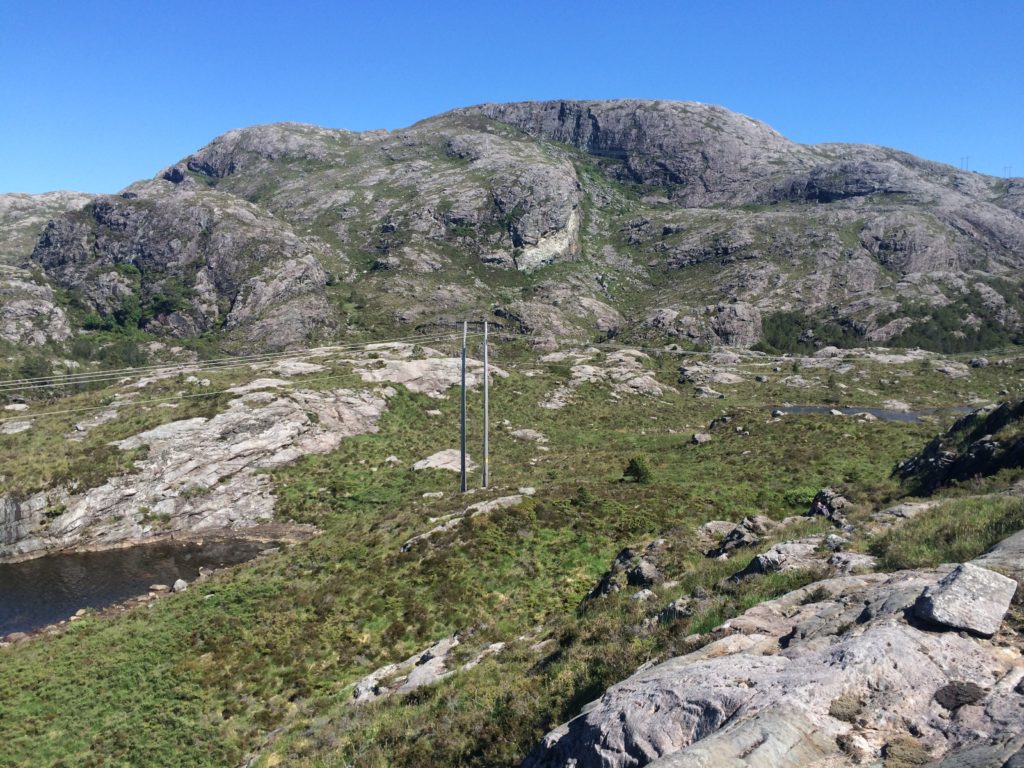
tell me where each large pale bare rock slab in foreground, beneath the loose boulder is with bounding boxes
[523,544,1024,768]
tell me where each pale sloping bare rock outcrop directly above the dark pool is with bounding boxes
[0,389,393,557]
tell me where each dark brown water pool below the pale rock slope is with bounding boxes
[0,540,270,637]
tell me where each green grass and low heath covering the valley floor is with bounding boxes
[0,345,1006,766]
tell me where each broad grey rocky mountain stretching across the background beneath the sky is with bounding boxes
[0,100,1024,351]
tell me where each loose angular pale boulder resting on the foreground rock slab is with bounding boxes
[913,563,1017,636]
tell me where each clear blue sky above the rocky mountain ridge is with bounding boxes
[0,0,1024,193]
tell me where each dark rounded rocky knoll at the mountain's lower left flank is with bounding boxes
[32,182,334,348]
